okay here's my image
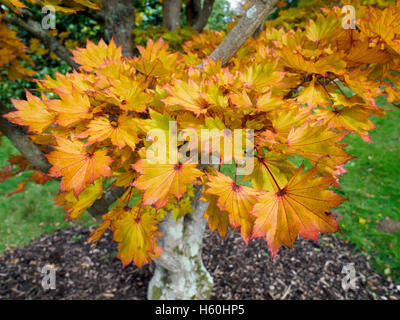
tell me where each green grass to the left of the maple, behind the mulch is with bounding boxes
[0,137,94,252]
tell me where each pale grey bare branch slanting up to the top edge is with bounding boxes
[210,0,278,65]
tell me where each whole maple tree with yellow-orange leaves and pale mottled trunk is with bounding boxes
[0,0,400,298]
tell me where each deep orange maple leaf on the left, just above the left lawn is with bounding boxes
[46,137,113,198]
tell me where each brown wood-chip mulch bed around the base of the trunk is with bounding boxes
[0,226,400,300]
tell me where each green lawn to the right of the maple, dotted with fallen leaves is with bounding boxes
[336,99,400,281]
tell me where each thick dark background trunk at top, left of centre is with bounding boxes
[103,0,135,57]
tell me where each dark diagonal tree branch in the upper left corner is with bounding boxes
[2,16,79,69]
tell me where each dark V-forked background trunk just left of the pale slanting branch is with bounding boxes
[186,0,215,32]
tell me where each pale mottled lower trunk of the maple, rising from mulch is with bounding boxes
[147,187,213,300]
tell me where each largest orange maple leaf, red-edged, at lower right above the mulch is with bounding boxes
[251,164,345,257]
